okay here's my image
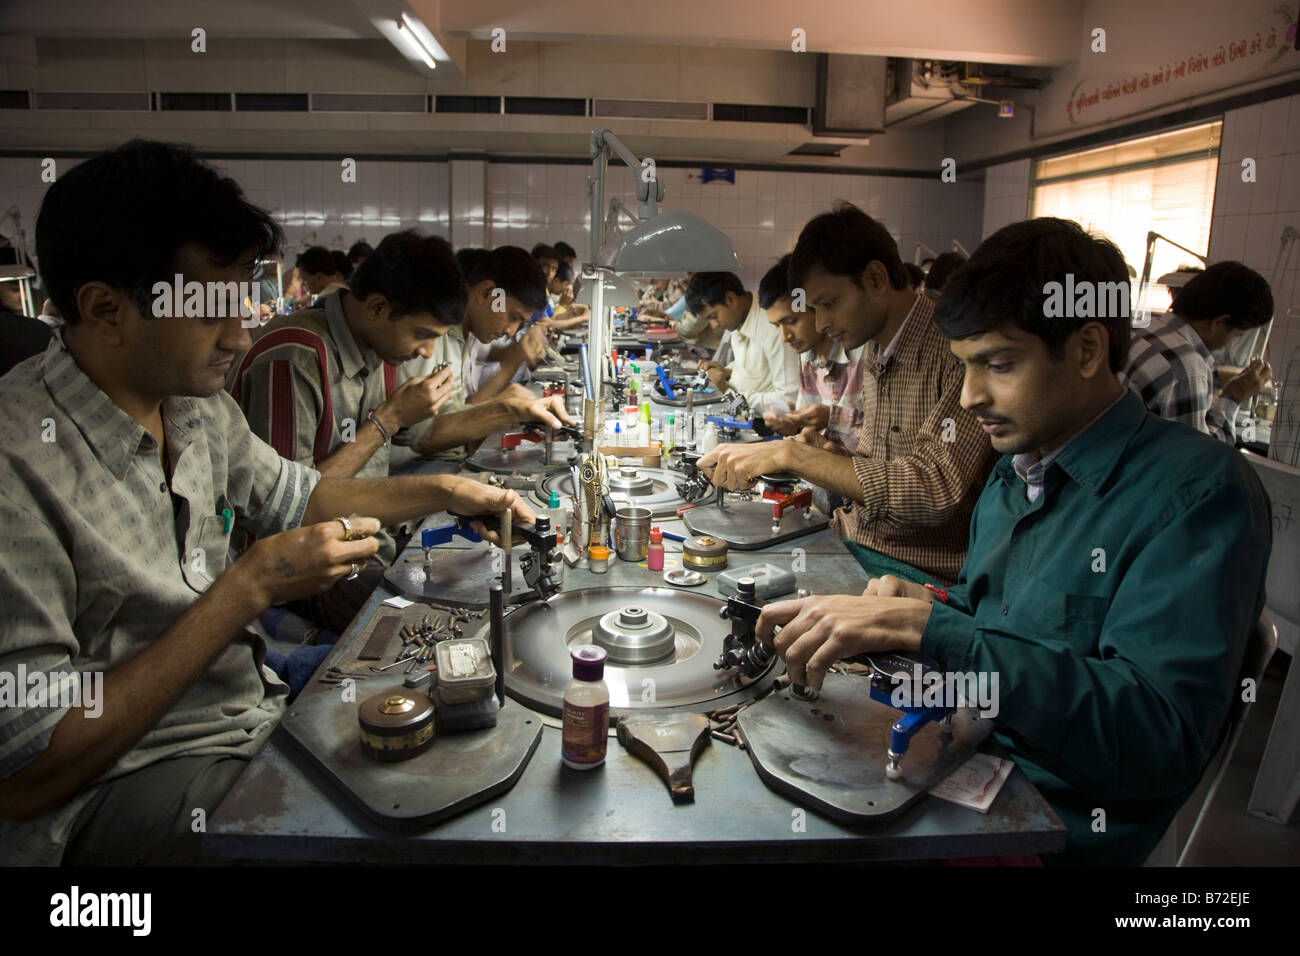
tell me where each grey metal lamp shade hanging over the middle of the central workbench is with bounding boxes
[595,209,740,278]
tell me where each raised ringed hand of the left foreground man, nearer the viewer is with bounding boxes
[231,518,380,607]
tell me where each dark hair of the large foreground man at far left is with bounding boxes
[36,139,285,325]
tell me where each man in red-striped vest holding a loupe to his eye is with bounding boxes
[231,239,563,633]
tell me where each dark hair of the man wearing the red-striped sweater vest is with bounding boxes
[351,229,465,325]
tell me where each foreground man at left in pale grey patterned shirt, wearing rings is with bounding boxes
[0,140,534,865]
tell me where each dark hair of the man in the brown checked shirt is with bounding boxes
[790,200,907,289]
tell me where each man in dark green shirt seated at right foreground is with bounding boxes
[759,219,1271,865]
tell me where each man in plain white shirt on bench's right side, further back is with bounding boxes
[686,272,800,414]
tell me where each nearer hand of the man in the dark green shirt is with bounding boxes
[755,594,931,691]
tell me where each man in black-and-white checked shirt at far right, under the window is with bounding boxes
[1121,261,1273,445]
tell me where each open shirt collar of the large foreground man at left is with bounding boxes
[40,328,203,480]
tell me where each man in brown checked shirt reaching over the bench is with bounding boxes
[699,203,996,584]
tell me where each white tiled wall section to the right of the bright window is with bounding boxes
[1209,95,1300,377]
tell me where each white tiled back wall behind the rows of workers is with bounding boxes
[0,159,987,287]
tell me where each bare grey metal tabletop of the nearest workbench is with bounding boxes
[204,468,1065,865]
